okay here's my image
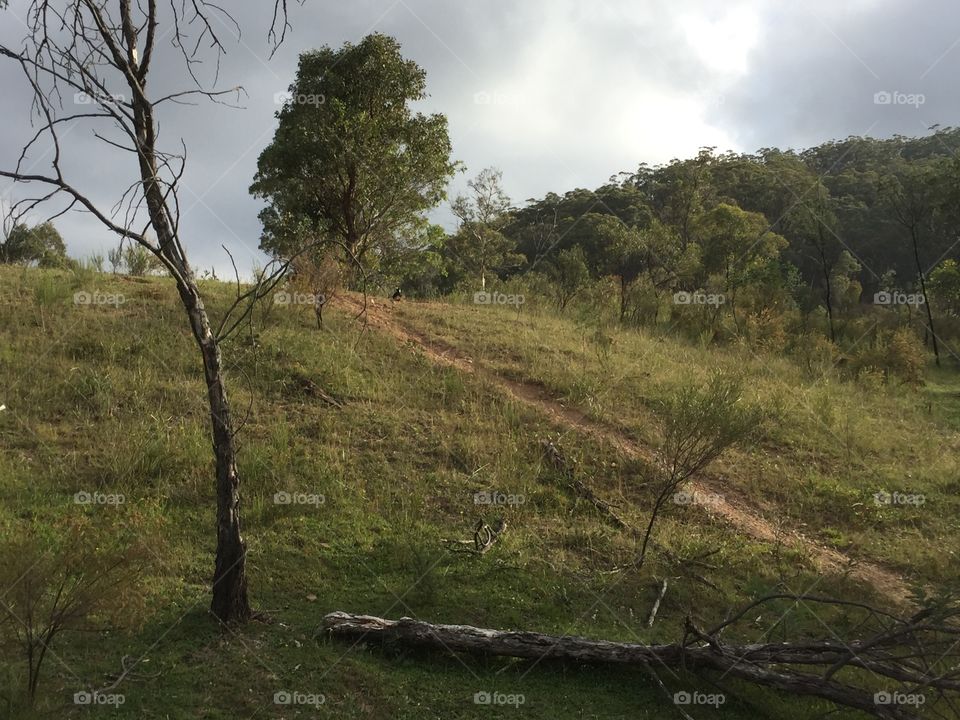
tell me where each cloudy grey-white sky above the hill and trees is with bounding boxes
[0,0,960,276]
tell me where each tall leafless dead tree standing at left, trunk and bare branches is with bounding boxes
[0,0,300,622]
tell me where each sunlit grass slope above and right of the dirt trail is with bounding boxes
[397,303,960,583]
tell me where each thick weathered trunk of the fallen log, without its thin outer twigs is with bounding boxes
[323,612,952,720]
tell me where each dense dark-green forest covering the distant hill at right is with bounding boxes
[432,128,960,302]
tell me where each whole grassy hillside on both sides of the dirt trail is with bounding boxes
[0,267,960,719]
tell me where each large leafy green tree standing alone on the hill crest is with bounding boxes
[250,33,456,276]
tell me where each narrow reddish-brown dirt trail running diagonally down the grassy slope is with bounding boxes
[336,295,909,605]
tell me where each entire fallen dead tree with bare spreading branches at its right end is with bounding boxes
[323,583,960,720]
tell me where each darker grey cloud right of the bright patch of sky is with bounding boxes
[717,0,960,149]
